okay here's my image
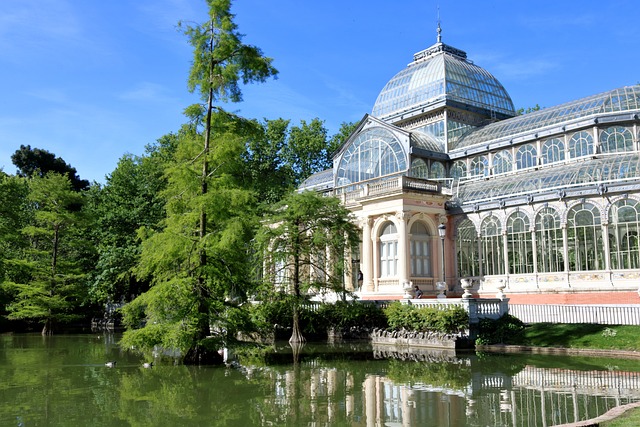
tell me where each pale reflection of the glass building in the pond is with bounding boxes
[245,359,640,427]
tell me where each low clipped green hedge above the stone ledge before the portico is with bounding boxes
[384,301,469,334]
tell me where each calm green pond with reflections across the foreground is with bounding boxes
[0,334,640,427]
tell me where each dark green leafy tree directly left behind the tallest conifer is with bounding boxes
[89,134,179,304]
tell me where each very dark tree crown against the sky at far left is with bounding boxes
[11,145,89,191]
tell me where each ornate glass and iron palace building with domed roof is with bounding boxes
[301,31,640,304]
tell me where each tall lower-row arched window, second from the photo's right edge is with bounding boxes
[567,203,604,271]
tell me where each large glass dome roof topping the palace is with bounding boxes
[371,36,515,122]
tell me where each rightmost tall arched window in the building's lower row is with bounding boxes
[609,199,640,270]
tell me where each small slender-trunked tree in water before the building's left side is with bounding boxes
[257,191,360,343]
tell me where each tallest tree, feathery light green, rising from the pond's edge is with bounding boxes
[123,0,277,364]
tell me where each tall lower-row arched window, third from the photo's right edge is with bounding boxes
[536,208,564,273]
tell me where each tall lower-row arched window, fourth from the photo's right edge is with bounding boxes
[507,212,533,274]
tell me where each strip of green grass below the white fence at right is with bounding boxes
[517,323,640,351]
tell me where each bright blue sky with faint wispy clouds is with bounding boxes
[0,0,640,183]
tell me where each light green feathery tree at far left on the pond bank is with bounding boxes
[6,172,87,335]
